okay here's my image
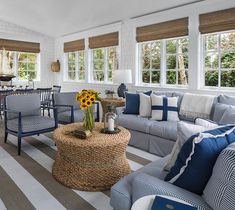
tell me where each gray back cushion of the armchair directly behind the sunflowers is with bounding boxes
[53,92,80,112]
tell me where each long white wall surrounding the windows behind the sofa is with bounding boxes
[52,0,235,94]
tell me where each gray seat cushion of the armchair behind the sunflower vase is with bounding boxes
[58,109,84,123]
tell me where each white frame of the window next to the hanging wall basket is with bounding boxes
[64,50,86,82]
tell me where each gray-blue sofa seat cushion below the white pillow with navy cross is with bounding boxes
[149,121,177,140]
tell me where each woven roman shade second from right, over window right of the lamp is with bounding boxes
[136,17,188,42]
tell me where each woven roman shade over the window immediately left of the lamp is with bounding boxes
[89,32,118,49]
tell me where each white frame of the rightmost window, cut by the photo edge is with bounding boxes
[200,30,235,90]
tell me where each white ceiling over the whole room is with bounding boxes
[0,0,202,37]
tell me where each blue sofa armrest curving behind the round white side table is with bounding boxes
[131,173,211,210]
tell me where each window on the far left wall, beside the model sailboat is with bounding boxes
[1,51,39,81]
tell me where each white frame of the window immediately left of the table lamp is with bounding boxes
[89,46,119,84]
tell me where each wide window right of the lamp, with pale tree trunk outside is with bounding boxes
[139,37,188,85]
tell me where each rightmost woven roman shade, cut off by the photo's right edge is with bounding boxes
[199,8,235,34]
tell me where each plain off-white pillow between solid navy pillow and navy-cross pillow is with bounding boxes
[139,93,152,117]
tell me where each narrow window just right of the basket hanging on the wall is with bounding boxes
[66,50,85,81]
